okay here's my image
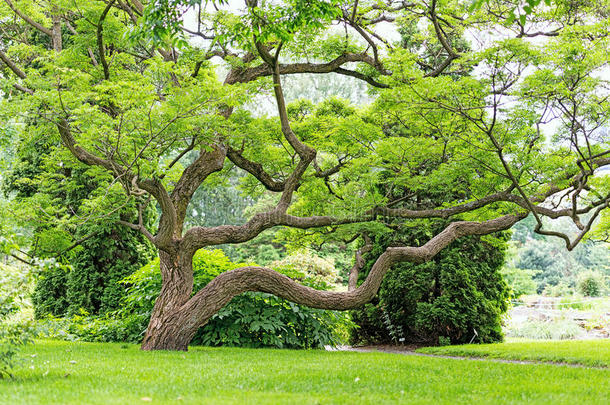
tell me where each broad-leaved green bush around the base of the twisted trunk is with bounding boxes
[41,250,351,348]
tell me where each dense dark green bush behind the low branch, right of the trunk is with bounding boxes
[352,230,509,344]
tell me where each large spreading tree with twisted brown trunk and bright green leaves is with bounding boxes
[0,0,610,350]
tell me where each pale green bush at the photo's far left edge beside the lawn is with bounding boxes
[0,264,33,378]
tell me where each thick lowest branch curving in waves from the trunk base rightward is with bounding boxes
[142,214,525,350]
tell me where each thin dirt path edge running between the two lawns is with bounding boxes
[334,346,608,370]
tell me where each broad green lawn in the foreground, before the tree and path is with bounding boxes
[0,341,610,404]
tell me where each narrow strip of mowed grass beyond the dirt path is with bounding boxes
[417,339,610,367]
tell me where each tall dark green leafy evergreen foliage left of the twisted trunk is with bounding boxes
[2,123,156,318]
